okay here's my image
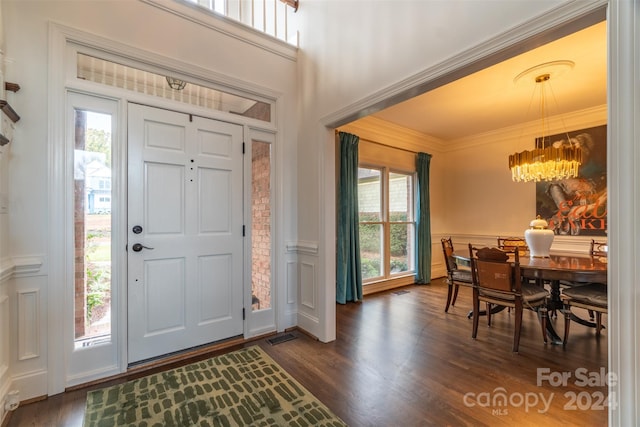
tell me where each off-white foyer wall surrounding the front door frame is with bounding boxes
[0,0,298,400]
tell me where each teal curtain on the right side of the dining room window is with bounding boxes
[416,153,431,284]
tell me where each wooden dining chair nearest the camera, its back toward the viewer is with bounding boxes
[469,244,549,353]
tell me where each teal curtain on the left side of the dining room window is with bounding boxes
[336,132,362,304]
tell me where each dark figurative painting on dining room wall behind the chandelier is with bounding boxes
[536,125,607,236]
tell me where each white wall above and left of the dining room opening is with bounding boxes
[298,0,564,341]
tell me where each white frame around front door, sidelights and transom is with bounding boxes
[43,23,282,395]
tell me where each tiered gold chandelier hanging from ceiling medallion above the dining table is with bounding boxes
[509,61,582,182]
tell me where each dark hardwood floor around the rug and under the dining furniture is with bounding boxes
[7,279,608,427]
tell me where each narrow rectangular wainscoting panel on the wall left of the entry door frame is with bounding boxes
[17,290,40,360]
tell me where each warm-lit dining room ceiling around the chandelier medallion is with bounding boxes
[372,21,607,141]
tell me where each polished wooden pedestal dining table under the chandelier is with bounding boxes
[454,251,607,344]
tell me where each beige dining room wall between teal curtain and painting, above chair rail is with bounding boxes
[444,106,607,237]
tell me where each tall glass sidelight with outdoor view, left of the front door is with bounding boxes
[73,109,112,348]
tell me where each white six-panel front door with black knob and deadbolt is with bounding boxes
[128,104,244,363]
